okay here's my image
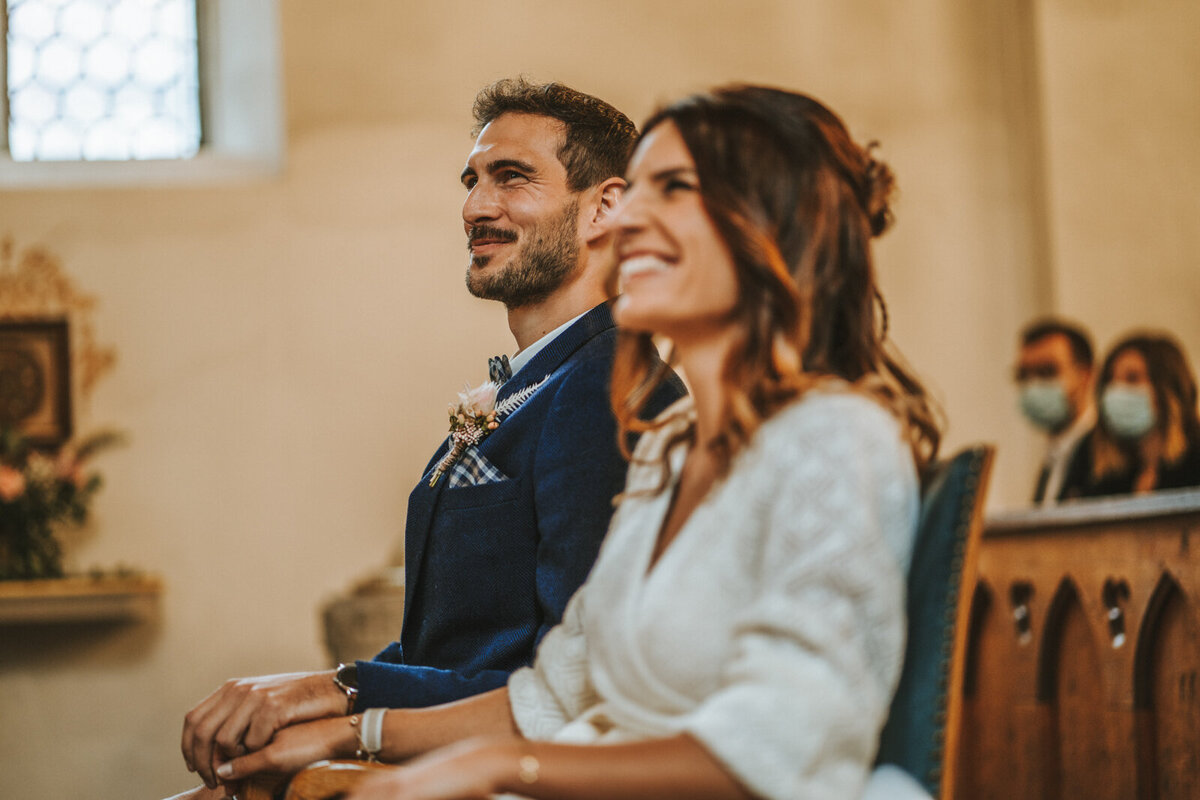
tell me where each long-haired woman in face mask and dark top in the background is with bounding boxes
[1084,333,1200,497]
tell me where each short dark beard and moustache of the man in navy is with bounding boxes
[467,199,580,308]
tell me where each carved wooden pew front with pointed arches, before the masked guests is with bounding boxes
[955,489,1200,800]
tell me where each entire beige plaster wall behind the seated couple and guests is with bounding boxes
[0,0,1200,800]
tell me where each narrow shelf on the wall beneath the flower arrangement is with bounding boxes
[0,576,162,625]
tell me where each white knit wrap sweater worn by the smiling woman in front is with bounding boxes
[509,390,918,800]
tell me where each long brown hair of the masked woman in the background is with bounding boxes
[1092,331,1200,481]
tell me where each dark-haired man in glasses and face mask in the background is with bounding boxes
[1016,319,1096,505]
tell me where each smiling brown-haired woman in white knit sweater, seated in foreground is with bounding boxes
[220,86,938,800]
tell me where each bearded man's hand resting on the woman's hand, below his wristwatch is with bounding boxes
[181,670,347,789]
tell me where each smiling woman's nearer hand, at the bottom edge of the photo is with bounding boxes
[347,739,520,800]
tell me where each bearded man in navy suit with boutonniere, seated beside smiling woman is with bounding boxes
[182,79,683,788]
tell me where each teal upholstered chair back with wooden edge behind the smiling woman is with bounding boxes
[877,445,994,798]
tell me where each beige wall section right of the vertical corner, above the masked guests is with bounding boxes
[1038,0,1200,355]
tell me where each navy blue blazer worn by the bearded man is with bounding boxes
[356,303,684,709]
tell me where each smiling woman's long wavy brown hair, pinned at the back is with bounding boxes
[612,85,941,485]
